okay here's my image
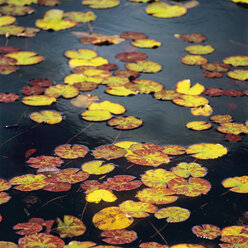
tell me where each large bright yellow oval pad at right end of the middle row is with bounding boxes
[186,143,227,159]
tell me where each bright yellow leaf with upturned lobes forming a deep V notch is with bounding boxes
[175,79,205,95]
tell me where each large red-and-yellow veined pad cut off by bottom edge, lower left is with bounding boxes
[18,233,65,248]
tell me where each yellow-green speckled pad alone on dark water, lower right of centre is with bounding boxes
[154,207,190,223]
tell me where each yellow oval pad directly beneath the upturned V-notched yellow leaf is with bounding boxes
[172,95,208,108]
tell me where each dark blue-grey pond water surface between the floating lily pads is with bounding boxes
[0,0,248,247]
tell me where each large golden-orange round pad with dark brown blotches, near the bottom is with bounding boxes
[92,207,133,231]
